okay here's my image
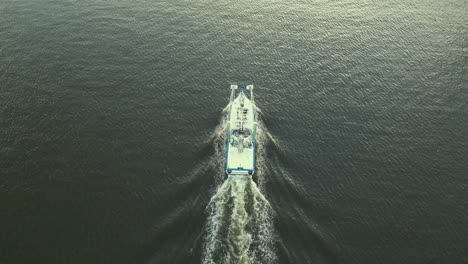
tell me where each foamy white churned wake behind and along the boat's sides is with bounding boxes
[203,107,276,264]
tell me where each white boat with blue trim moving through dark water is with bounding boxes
[226,85,257,176]
